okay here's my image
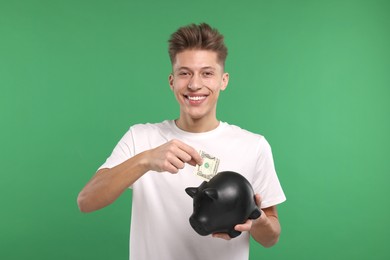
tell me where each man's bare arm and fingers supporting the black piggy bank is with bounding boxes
[213,194,281,247]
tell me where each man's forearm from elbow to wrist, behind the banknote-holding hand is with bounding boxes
[77,150,148,212]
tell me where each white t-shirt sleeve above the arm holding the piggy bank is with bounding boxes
[253,137,286,208]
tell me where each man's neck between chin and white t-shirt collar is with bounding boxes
[175,117,219,133]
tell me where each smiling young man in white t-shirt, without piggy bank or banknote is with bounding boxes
[78,24,285,260]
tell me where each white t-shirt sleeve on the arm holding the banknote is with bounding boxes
[98,128,134,170]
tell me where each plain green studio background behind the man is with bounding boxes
[0,0,390,260]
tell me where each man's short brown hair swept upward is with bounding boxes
[168,23,228,67]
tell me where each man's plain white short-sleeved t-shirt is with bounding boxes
[99,120,286,260]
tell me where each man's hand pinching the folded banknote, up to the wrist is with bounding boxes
[148,140,202,173]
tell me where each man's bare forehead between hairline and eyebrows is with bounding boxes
[172,50,222,70]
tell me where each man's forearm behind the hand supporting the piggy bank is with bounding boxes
[250,209,281,247]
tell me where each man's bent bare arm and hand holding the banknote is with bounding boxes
[77,140,202,212]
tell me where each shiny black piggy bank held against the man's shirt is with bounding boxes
[185,171,261,238]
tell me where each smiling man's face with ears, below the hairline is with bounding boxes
[169,50,229,126]
